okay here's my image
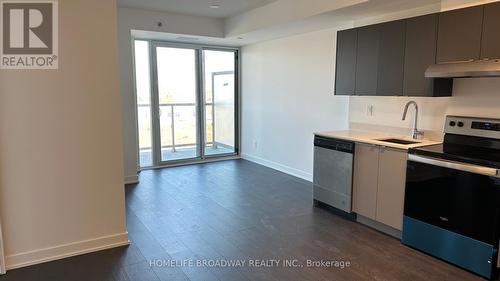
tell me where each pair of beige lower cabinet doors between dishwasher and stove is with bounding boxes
[353,143,408,230]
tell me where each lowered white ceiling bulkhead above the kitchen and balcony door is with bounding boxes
[132,0,446,46]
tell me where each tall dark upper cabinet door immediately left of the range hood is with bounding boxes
[403,14,438,96]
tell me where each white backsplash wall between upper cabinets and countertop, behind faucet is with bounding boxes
[349,78,500,136]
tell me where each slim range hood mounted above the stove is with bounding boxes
[425,59,500,78]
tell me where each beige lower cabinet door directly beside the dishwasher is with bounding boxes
[352,143,380,220]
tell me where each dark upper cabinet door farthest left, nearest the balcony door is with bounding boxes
[335,29,358,95]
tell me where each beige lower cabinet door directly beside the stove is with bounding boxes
[376,145,408,230]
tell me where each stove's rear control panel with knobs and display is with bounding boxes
[444,116,500,139]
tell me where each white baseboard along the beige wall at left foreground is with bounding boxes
[5,232,130,270]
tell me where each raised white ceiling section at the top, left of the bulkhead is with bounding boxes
[118,0,275,18]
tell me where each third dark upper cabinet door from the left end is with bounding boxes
[376,20,406,96]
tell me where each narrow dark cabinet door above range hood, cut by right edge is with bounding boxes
[481,2,500,59]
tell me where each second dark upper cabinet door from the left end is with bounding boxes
[355,24,380,96]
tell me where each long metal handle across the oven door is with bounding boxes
[408,154,500,178]
